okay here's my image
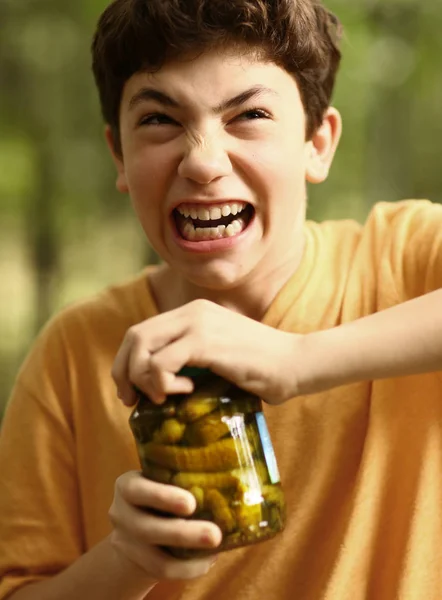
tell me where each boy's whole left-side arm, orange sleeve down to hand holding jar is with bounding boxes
[0,324,221,600]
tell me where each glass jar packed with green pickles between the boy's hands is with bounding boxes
[129,368,285,558]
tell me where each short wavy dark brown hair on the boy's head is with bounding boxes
[92,0,341,151]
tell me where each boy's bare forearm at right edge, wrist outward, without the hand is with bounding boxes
[298,290,442,394]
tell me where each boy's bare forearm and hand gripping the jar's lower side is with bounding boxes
[6,472,222,600]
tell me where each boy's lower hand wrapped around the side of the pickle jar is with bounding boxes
[109,471,222,583]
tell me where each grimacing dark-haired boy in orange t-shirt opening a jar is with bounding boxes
[0,0,442,600]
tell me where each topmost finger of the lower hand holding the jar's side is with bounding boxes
[121,473,196,517]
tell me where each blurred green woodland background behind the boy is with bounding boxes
[0,0,442,415]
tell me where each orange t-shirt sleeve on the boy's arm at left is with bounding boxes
[0,316,84,600]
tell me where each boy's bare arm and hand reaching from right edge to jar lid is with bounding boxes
[113,289,442,405]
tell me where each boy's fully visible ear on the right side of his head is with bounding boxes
[306,107,342,183]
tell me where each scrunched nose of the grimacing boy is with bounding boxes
[178,135,232,185]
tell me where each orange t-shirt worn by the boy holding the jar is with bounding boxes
[0,201,442,600]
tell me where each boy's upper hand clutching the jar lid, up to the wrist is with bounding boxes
[112,300,304,406]
